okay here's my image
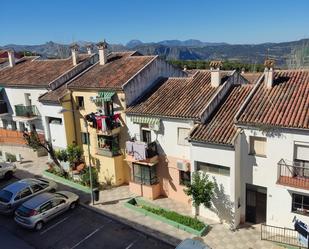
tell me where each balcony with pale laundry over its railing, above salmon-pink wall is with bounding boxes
[126,141,158,164]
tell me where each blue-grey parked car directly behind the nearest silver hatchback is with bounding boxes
[0,178,57,214]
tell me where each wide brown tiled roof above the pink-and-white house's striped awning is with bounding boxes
[126,70,227,119]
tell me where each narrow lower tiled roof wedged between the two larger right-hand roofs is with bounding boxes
[190,84,254,145]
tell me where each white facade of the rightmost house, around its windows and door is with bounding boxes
[240,127,309,228]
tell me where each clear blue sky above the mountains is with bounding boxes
[0,0,309,45]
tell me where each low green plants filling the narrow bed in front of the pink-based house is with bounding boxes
[141,205,205,231]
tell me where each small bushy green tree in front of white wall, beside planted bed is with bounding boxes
[184,172,214,217]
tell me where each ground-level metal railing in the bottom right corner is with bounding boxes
[261,224,307,248]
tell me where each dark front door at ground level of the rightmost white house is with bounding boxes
[246,184,267,224]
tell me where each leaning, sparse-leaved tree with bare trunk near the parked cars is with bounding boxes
[23,131,64,173]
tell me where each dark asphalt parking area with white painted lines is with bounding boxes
[0,179,174,249]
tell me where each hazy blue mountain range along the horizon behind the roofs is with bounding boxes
[0,39,309,67]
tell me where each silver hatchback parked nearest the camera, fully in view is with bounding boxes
[14,191,79,230]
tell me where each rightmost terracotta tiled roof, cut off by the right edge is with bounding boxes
[238,70,309,129]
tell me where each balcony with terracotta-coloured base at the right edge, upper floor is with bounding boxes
[277,159,309,190]
